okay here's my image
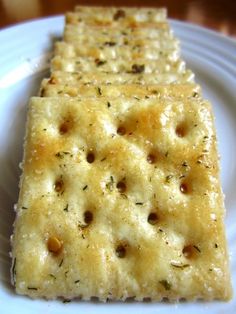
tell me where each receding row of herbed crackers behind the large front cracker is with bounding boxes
[40,6,200,97]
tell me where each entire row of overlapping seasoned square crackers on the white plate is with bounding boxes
[12,6,231,301]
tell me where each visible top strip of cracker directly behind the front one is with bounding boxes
[39,79,201,99]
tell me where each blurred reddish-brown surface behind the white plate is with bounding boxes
[0,0,236,38]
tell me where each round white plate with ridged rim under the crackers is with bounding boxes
[0,17,236,314]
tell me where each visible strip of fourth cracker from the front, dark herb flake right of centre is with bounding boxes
[51,53,185,74]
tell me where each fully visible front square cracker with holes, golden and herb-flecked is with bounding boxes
[12,98,231,301]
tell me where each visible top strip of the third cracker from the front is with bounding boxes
[43,70,194,86]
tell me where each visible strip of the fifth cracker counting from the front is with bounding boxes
[54,37,180,59]
